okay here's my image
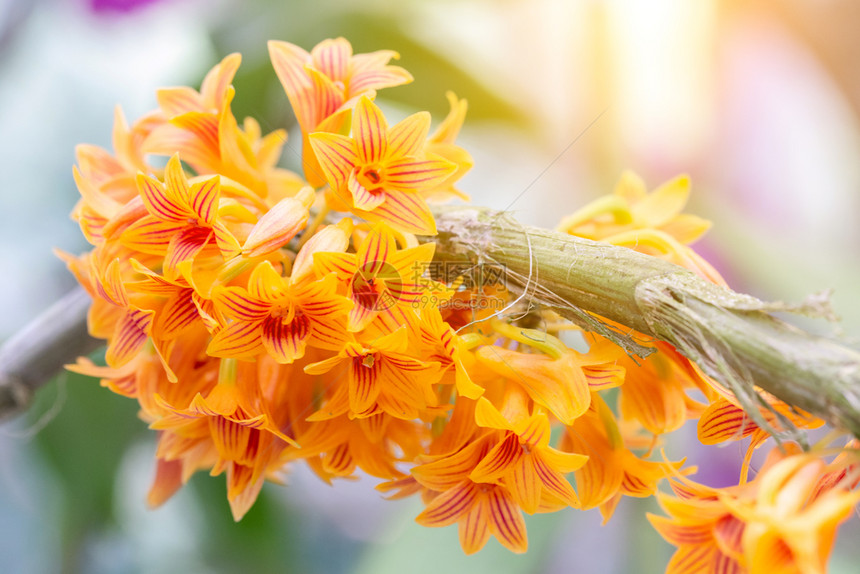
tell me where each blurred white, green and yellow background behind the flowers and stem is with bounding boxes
[0,0,860,574]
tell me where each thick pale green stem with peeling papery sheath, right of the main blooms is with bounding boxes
[434,208,860,437]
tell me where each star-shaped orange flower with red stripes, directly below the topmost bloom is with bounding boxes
[309,97,457,235]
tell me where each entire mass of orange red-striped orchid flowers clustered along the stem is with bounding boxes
[63,38,856,572]
